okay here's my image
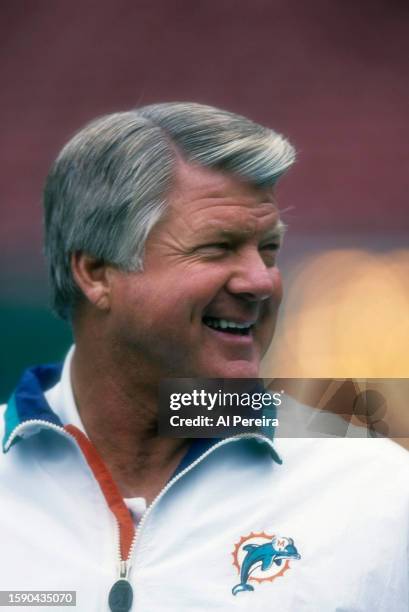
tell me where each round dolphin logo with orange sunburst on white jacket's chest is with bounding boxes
[232,532,301,595]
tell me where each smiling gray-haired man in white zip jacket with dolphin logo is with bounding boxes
[0,103,409,612]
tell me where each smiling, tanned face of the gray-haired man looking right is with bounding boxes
[110,164,282,379]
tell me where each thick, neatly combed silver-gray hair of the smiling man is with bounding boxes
[44,102,295,318]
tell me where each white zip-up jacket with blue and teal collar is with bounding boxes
[0,352,409,612]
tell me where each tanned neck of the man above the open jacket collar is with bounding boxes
[71,342,188,502]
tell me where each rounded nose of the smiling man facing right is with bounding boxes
[227,249,281,302]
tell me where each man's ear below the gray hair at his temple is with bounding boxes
[71,251,111,310]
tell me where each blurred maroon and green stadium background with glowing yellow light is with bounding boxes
[0,0,409,400]
